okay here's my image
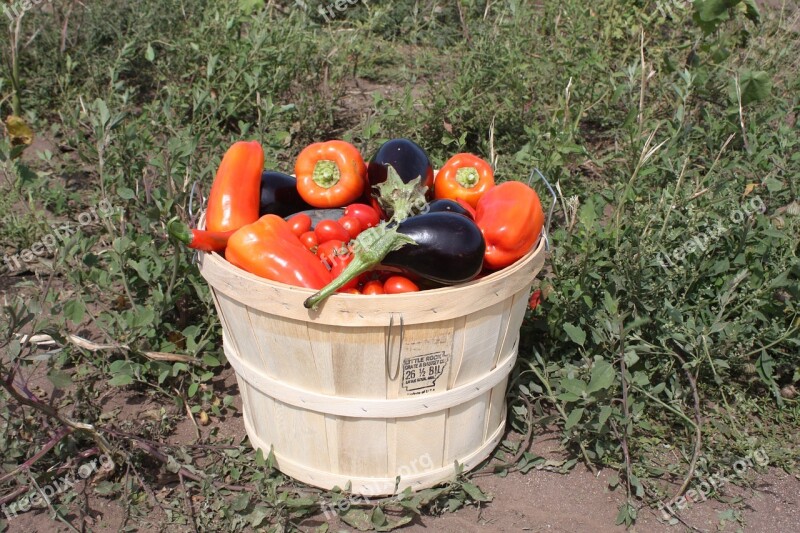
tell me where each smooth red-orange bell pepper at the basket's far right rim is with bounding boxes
[475,181,544,270]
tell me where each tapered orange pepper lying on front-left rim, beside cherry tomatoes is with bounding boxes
[225,215,333,289]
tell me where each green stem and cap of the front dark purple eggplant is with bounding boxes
[303,224,417,309]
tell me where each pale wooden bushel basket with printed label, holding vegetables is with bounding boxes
[199,170,546,496]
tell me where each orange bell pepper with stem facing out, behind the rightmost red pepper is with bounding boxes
[433,154,494,207]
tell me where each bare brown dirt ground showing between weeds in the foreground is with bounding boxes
[9,369,800,533]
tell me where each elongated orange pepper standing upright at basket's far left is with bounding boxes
[206,141,264,231]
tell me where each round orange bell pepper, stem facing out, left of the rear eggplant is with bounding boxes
[294,141,368,208]
